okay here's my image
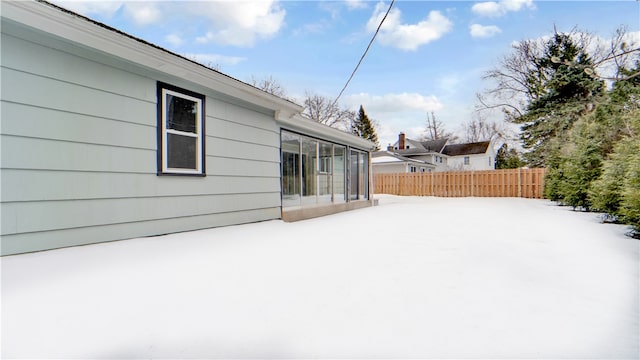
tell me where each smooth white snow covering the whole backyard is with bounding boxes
[1,195,640,359]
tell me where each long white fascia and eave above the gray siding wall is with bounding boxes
[0,1,304,112]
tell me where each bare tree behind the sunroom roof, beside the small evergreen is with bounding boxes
[302,92,356,130]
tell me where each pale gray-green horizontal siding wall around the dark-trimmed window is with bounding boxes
[0,24,280,255]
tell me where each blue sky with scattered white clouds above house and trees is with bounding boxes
[55,0,640,147]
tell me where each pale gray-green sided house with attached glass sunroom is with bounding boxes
[0,1,375,255]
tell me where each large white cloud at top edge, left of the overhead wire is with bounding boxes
[190,0,286,47]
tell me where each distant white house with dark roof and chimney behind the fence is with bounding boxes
[373,132,496,173]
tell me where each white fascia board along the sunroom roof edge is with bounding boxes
[276,111,376,151]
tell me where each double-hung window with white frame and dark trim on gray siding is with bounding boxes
[158,83,205,176]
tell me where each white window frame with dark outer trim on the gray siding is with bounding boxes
[158,84,205,176]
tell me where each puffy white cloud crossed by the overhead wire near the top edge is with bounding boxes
[367,2,453,50]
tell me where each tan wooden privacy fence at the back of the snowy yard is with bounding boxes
[373,168,546,199]
